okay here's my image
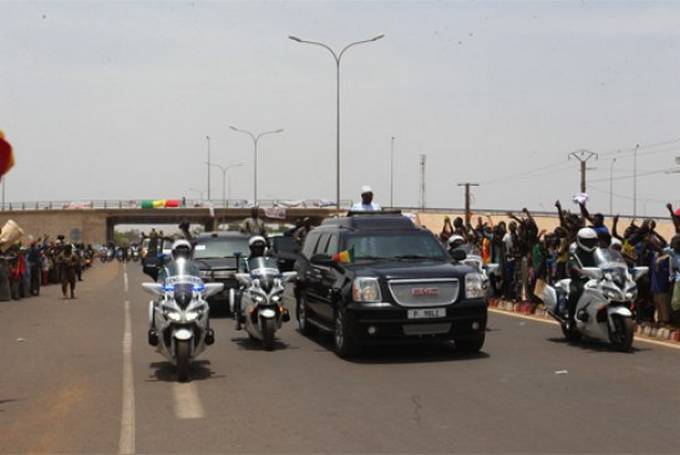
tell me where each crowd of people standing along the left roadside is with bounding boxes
[0,235,95,301]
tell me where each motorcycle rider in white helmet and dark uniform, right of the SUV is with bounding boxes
[567,228,599,330]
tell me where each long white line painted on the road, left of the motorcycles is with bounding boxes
[118,264,135,454]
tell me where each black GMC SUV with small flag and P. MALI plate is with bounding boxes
[295,213,487,358]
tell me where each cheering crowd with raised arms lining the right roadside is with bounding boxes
[439,201,680,326]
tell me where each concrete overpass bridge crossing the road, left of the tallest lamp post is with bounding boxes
[0,207,336,243]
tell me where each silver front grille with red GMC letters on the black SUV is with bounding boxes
[387,278,460,307]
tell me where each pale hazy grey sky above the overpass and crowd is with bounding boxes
[0,0,680,215]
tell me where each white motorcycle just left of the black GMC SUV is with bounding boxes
[229,257,297,351]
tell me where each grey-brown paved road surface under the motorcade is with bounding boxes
[0,263,680,453]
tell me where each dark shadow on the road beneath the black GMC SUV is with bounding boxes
[298,332,491,365]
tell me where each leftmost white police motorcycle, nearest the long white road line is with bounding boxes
[142,259,224,381]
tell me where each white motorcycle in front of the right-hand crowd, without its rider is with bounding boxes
[543,248,649,352]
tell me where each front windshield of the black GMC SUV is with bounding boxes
[345,232,447,260]
